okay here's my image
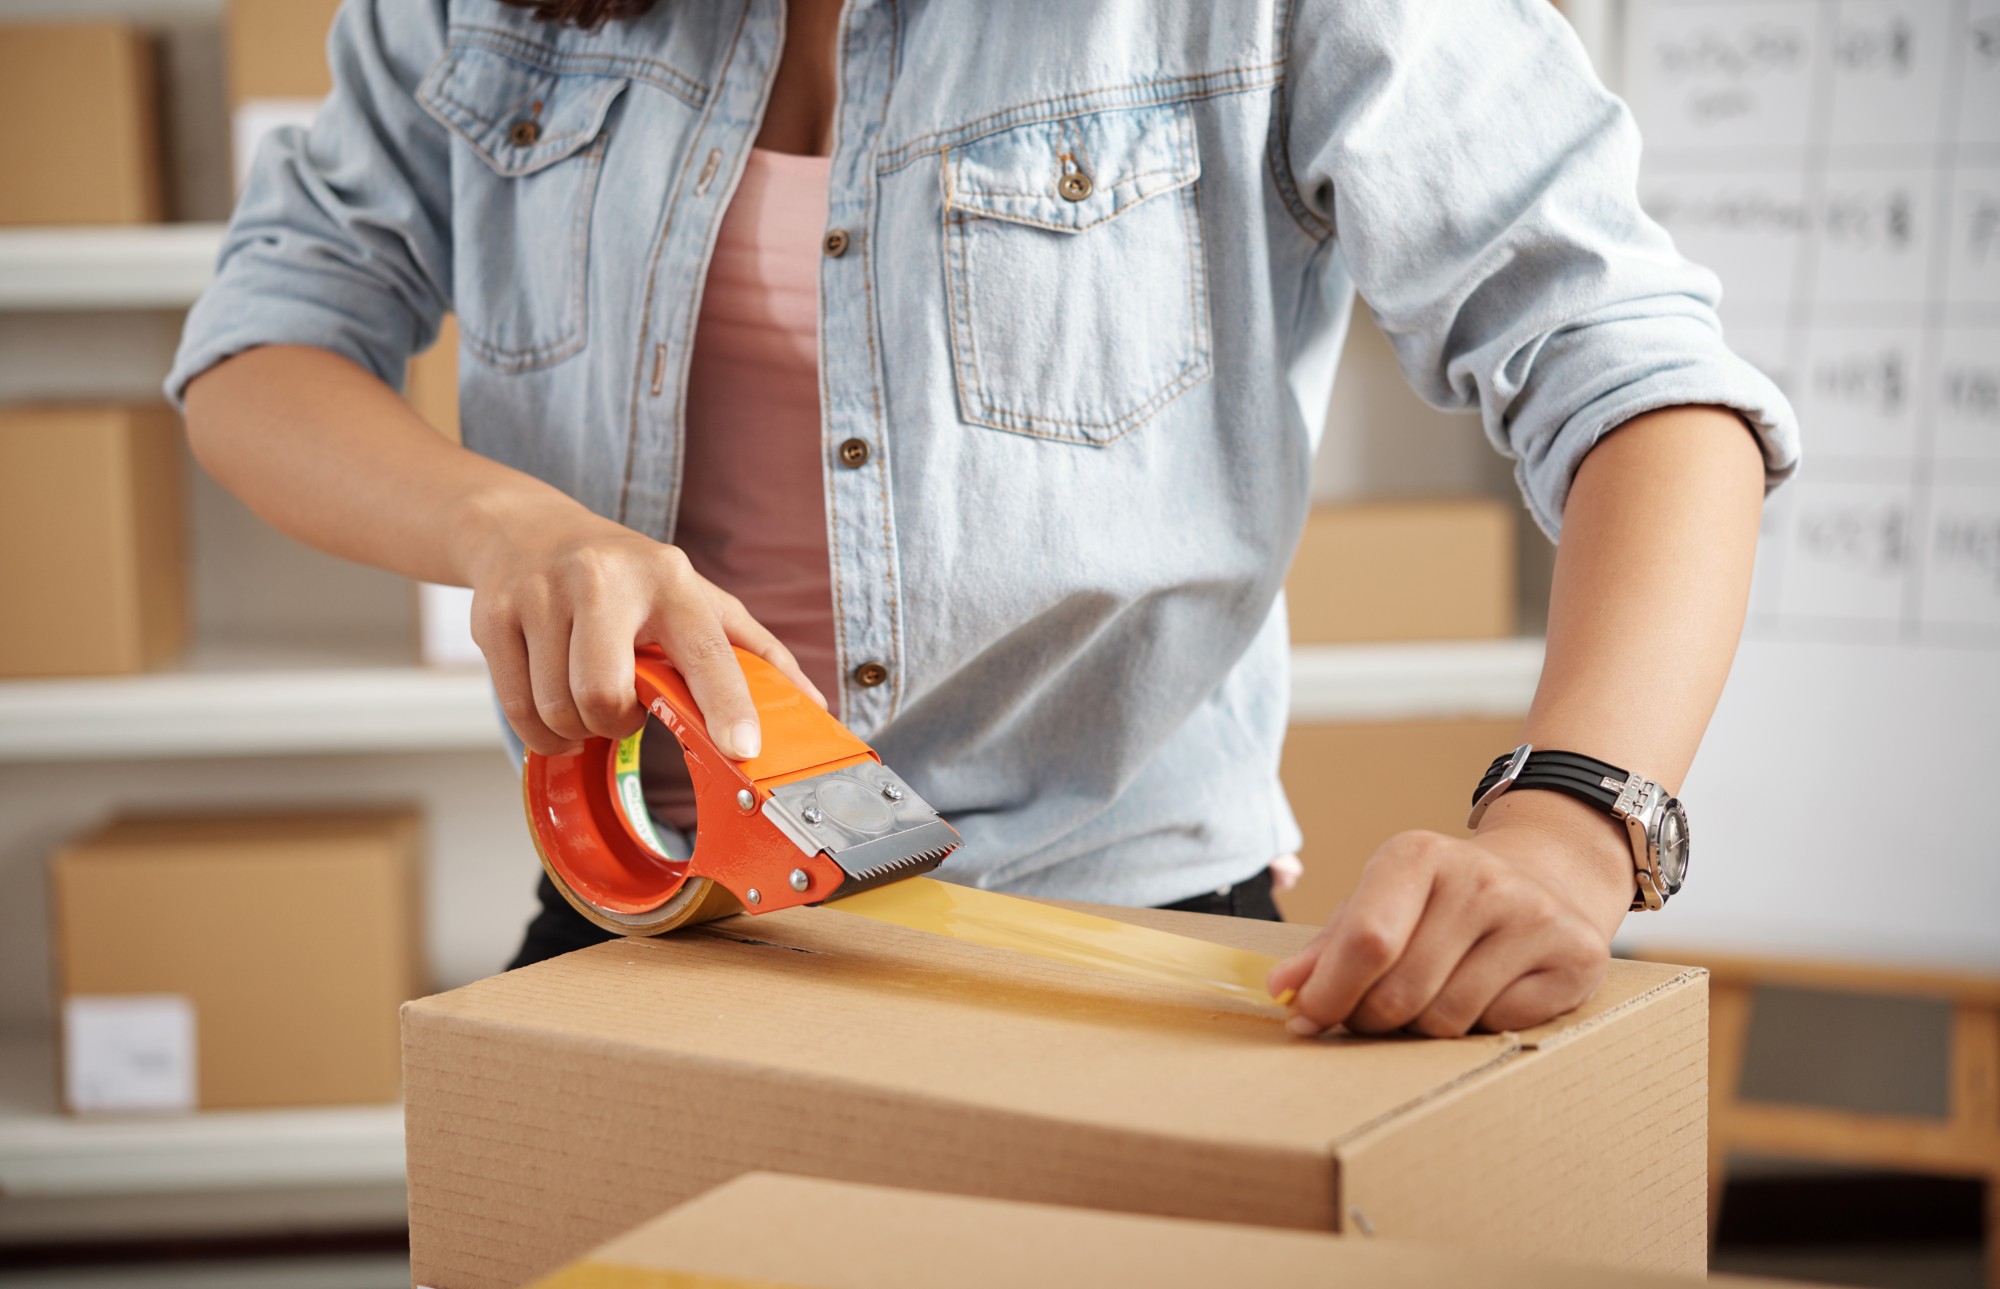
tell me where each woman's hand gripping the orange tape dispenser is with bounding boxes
[456,496,826,761]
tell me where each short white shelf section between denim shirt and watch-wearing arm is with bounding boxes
[1292,636,1544,725]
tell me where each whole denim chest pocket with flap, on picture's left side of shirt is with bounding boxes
[416,46,628,372]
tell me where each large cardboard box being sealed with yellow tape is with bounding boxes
[404,909,1708,1289]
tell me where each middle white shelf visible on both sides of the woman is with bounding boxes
[0,638,1542,763]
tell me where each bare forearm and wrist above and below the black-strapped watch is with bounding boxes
[1480,406,1764,933]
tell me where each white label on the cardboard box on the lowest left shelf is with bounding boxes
[62,993,194,1111]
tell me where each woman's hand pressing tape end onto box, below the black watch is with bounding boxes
[1270,793,1632,1039]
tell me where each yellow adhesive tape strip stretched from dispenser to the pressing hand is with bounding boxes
[826,877,1292,1007]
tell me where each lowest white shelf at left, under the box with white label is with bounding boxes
[0,1037,402,1201]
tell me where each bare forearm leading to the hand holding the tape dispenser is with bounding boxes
[188,346,582,584]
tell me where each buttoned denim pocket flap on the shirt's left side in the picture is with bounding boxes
[416,44,628,176]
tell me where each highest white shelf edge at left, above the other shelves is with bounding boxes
[0,224,222,310]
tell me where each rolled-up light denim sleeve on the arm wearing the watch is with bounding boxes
[1282,0,1798,536]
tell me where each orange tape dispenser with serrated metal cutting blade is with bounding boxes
[522,647,958,935]
